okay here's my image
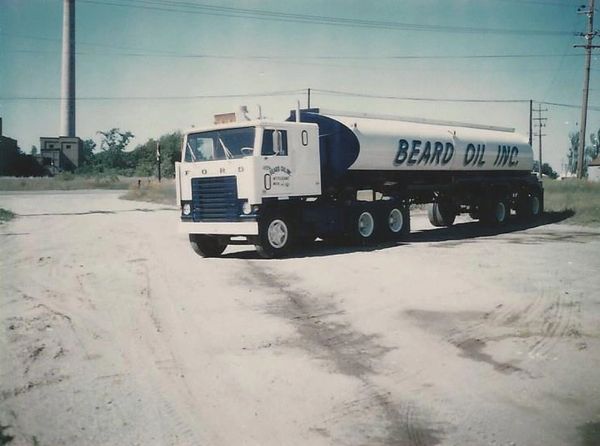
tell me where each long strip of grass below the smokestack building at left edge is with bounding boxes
[0,173,138,191]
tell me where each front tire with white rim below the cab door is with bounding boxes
[256,213,294,259]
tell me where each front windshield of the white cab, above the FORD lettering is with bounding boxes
[184,127,256,162]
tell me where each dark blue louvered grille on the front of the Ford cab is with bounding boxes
[192,176,241,221]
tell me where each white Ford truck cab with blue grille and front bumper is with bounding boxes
[175,120,321,242]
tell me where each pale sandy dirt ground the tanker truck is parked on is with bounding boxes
[0,191,600,446]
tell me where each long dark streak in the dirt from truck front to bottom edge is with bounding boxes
[246,261,441,446]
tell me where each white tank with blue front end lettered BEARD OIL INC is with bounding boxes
[289,109,533,189]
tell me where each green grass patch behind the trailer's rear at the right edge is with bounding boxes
[544,180,600,226]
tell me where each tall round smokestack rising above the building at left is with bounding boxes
[60,0,75,137]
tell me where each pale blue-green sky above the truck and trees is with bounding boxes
[0,0,600,172]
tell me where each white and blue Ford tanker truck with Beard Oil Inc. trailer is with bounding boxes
[175,108,544,258]
